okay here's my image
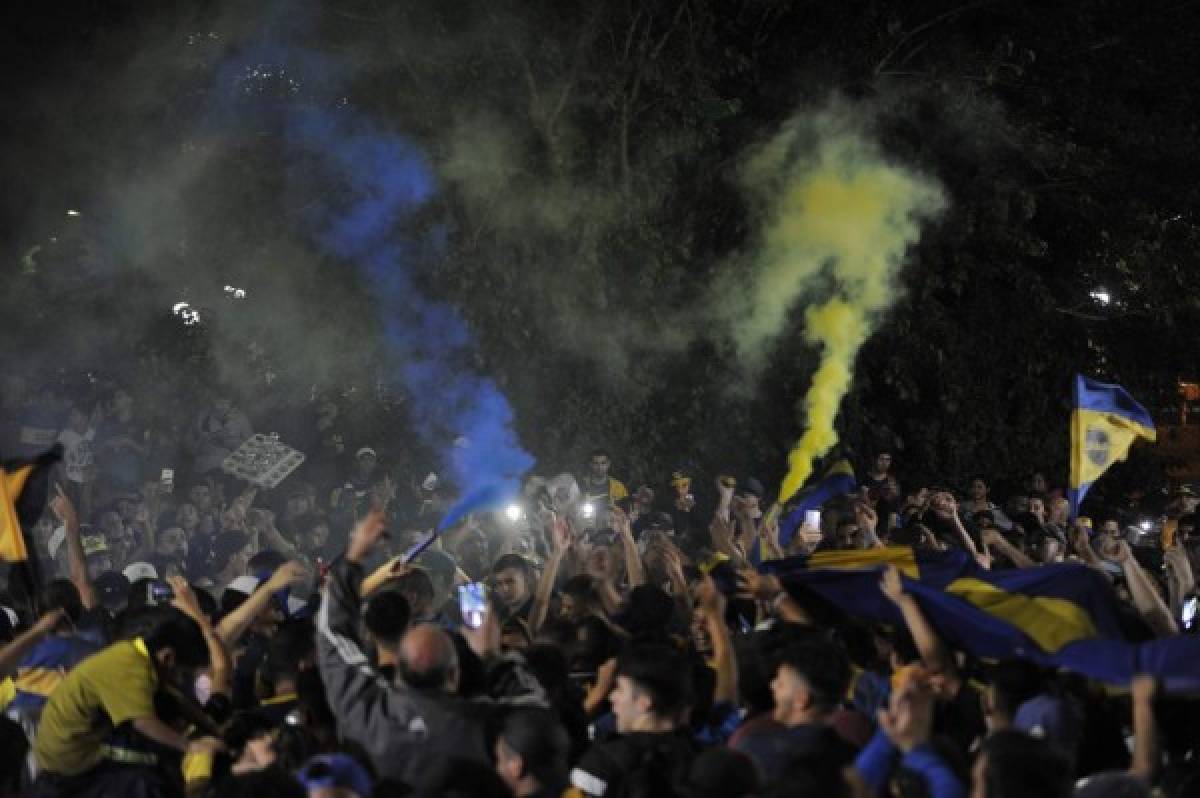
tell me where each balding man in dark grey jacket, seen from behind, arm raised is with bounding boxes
[317,508,547,785]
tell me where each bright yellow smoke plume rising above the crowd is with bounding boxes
[734,107,944,503]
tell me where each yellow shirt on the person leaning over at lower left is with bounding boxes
[34,638,157,775]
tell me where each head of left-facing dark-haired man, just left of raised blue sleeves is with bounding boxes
[770,640,850,726]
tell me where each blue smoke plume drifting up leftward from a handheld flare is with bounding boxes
[214,18,534,529]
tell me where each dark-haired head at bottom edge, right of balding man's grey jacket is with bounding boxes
[494,709,570,798]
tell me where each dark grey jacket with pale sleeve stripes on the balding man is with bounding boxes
[317,559,547,785]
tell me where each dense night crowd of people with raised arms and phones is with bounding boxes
[0,381,1200,798]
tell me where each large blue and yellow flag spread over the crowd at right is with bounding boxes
[764,546,1200,691]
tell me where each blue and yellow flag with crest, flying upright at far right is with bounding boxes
[1067,374,1156,517]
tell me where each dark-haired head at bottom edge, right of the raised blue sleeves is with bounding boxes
[971,730,1072,798]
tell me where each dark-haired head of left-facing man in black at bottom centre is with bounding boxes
[608,644,691,733]
